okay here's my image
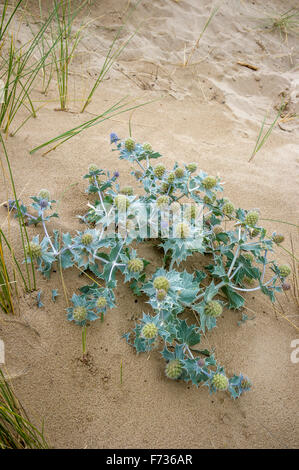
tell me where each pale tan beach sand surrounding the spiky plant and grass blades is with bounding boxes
[0,0,299,448]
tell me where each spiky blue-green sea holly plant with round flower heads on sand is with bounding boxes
[10,133,291,398]
